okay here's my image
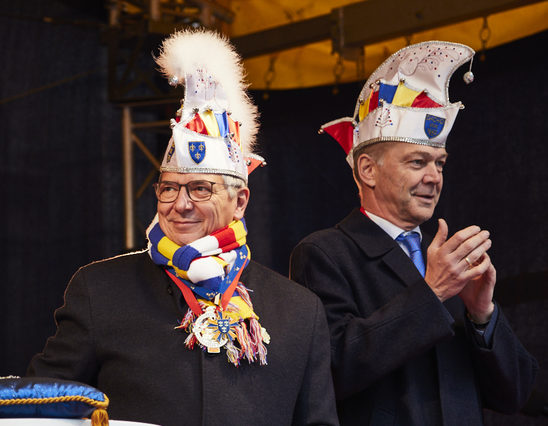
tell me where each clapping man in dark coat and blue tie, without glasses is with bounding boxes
[291,42,537,426]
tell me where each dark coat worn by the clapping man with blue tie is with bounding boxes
[291,209,537,426]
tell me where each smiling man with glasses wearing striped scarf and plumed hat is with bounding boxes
[29,31,338,426]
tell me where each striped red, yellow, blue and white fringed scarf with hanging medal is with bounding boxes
[147,218,270,366]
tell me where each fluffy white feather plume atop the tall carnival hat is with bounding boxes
[156,30,259,155]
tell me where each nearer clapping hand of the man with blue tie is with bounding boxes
[424,219,491,302]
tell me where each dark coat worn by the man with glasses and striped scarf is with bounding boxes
[28,252,338,426]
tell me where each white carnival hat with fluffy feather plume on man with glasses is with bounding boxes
[156,30,264,182]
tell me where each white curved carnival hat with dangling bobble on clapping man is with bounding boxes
[320,41,475,167]
